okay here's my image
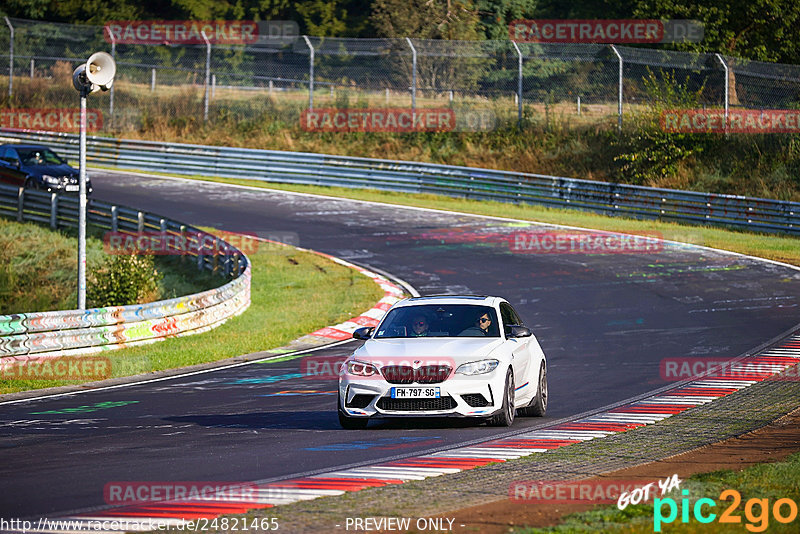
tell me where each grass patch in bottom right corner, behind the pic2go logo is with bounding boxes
[514,453,800,534]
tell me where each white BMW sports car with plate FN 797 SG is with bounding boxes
[338,296,547,429]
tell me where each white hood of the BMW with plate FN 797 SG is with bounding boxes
[353,337,503,366]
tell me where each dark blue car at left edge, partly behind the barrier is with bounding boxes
[0,144,92,194]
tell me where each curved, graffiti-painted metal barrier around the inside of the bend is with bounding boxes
[0,184,250,364]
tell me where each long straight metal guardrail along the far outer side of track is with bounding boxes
[0,130,800,235]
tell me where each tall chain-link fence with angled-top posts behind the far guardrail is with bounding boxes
[0,19,800,134]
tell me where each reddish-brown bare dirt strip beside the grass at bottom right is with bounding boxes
[446,409,800,534]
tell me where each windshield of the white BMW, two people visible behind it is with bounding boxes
[375,304,500,338]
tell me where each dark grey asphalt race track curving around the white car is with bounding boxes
[0,171,800,517]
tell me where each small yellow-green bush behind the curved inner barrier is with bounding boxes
[86,255,162,308]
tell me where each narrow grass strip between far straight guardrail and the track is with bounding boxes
[104,171,800,266]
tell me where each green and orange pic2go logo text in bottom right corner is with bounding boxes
[653,489,797,532]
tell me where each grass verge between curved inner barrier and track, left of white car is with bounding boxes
[0,228,383,394]
